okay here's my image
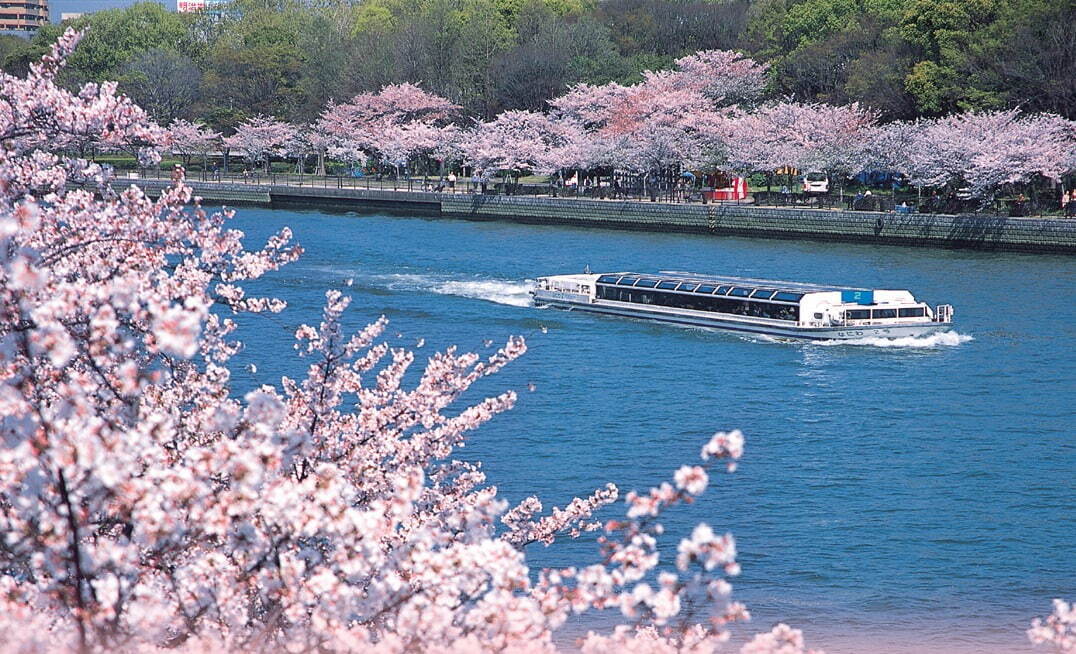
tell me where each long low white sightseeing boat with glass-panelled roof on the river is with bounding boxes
[530,272,952,341]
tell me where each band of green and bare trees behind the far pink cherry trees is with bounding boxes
[0,0,1076,131]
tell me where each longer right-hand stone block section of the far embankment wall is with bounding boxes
[441,196,1076,254]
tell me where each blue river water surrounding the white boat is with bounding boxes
[222,209,1076,653]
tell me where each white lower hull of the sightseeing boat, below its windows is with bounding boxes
[534,292,951,341]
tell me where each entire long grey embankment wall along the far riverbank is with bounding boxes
[117,180,1076,254]
